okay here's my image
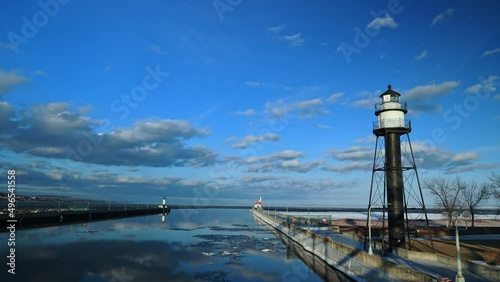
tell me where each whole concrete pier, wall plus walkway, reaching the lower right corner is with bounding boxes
[253,208,500,282]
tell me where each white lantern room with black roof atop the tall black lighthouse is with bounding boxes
[373,85,411,136]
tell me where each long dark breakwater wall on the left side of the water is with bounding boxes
[0,208,170,231]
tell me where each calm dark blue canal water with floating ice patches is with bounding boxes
[0,209,323,282]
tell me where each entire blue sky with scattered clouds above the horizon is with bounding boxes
[0,0,500,206]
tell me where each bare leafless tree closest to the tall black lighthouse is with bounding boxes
[423,176,465,225]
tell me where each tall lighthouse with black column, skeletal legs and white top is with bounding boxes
[365,85,432,252]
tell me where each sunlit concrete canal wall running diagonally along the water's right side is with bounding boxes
[252,210,439,281]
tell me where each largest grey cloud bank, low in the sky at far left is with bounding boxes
[0,103,217,167]
